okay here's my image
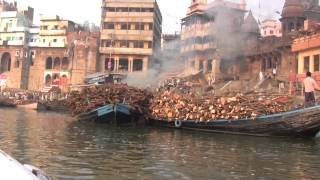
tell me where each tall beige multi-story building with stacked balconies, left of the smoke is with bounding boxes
[99,0,162,73]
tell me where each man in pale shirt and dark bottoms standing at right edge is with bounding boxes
[303,72,320,107]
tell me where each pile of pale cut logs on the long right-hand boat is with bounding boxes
[149,91,294,122]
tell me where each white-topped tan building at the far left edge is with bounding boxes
[0,5,33,88]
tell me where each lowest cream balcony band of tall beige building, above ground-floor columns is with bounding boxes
[100,47,152,56]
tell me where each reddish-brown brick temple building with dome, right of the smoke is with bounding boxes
[241,0,320,81]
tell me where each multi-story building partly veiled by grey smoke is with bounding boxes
[181,0,246,78]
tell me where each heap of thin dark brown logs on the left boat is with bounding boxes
[68,84,152,115]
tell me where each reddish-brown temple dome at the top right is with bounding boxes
[282,0,304,18]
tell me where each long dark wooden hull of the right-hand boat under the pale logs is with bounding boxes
[150,106,320,137]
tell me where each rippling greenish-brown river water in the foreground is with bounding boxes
[0,109,320,180]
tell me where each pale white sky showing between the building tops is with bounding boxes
[13,0,284,33]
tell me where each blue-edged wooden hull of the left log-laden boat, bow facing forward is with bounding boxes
[77,103,136,125]
